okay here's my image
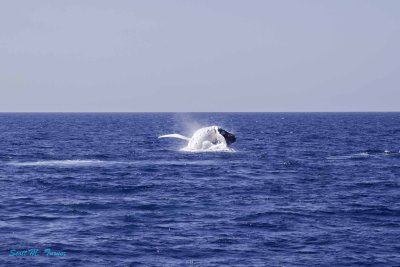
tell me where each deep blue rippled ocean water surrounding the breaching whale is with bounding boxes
[0,113,400,266]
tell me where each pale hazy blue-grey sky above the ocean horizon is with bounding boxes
[0,0,400,112]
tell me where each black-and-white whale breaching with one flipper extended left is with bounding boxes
[158,126,236,151]
